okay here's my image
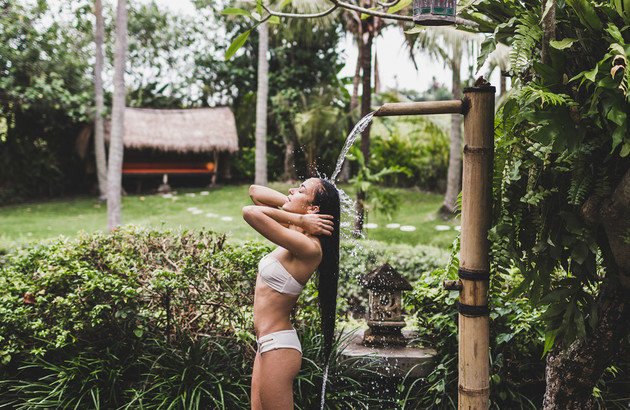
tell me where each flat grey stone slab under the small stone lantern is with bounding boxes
[341,330,437,378]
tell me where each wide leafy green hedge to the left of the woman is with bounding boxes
[0,229,262,408]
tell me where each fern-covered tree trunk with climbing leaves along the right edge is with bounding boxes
[469,0,630,408]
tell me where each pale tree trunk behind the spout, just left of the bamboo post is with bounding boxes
[440,47,462,215]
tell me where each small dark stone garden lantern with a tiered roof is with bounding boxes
[360,263,413,346]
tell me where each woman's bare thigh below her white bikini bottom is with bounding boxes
[260,349,302,410]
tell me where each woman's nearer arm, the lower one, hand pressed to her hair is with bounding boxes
[243,205,333,257]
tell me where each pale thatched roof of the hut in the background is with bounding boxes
[105,107,238,152]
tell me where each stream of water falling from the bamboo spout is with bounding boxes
[320,111,375,410]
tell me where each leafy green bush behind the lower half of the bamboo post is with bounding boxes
[400,243,545,409]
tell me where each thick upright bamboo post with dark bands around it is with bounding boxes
[458,86,495,410]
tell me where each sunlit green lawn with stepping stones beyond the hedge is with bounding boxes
[0,183,459,248]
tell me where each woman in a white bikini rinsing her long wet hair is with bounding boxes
[243,178,340,410]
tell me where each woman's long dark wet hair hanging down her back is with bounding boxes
[313,178,341,363]
